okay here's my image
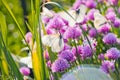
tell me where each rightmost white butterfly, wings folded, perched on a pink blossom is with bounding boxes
[94,12,108,29]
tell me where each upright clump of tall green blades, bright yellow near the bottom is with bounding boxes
[31,0,46,80]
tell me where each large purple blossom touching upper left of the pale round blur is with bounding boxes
[51,58,70,72]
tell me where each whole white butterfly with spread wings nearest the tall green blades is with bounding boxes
[42,34,64,52]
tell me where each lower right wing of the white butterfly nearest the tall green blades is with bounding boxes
[51,37,64,52]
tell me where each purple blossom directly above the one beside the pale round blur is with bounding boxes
[58,50,74,61]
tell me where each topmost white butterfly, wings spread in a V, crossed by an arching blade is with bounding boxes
[58,4,87,26]
